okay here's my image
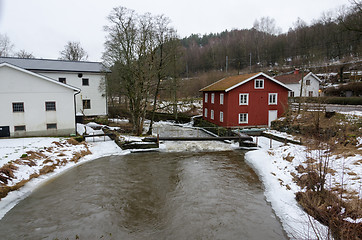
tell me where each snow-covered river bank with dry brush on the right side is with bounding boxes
[245,137,362,239]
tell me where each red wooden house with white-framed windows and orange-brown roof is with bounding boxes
[200,72,291,128]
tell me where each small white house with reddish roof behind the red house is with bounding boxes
[274,70,321,97]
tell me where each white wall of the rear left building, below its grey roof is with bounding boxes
[38,72,108,116]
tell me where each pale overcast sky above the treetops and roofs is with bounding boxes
[0,0,349,61]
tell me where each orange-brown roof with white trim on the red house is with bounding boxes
[200,72,291,92]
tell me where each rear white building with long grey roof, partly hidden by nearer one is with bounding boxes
[0,57,109,119]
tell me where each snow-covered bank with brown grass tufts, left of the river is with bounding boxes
[0,135,129,219]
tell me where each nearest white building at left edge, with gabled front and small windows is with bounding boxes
[0,63,80,137]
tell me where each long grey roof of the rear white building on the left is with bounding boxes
[0,57,110,73]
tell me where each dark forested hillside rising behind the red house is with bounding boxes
[181,3,362,75]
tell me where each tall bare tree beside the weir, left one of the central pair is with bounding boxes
[103,7,154,135]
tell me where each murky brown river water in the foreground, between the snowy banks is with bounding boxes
[0,151,286,240]
